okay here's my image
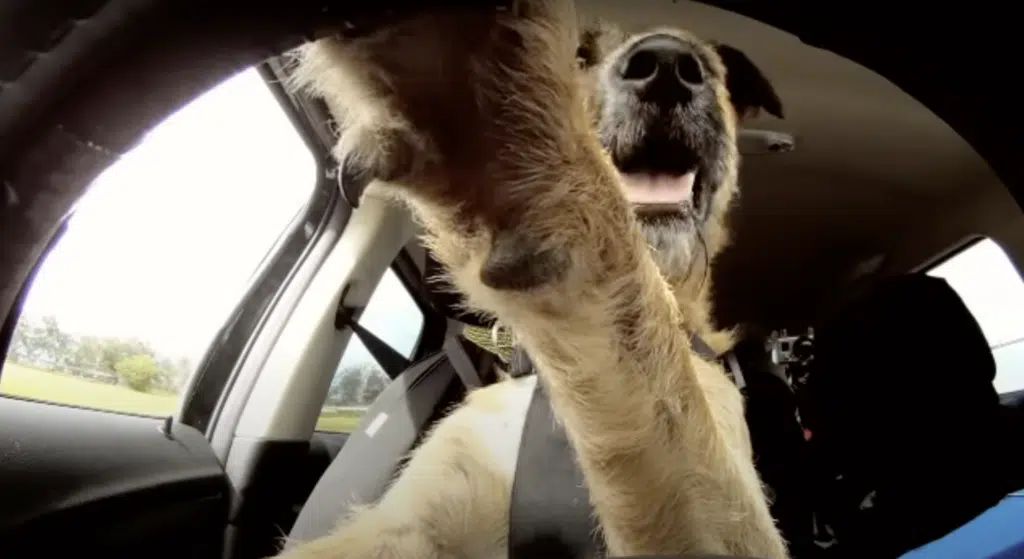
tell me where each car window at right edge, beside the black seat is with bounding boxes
[928,239,1024,393]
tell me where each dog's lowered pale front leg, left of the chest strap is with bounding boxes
[278,385,520,559]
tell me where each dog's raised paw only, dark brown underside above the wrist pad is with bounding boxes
[294,0,575,179]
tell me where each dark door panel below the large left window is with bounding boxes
[0,397,230,559]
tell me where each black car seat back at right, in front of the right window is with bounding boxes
[806,274,1020,557]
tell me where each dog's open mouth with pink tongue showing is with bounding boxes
[614,136,705,218]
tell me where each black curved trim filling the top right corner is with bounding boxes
[696,0,1024,208]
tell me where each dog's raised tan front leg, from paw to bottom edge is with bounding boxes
[292,0,786,558]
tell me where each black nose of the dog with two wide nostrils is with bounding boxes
[620,35,705,104]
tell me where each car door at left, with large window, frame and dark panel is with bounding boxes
[0,62,338,559]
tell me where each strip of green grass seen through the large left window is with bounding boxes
[0,361,178,417]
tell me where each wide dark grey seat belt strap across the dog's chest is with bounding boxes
[508,336,724,559]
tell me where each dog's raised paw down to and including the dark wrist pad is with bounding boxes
[298,0,589,290]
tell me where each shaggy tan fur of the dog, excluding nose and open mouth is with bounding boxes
[285,0,786,559]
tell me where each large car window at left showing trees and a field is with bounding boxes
[0,69,316,416]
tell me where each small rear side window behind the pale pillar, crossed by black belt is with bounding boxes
[316,268,424,433]
